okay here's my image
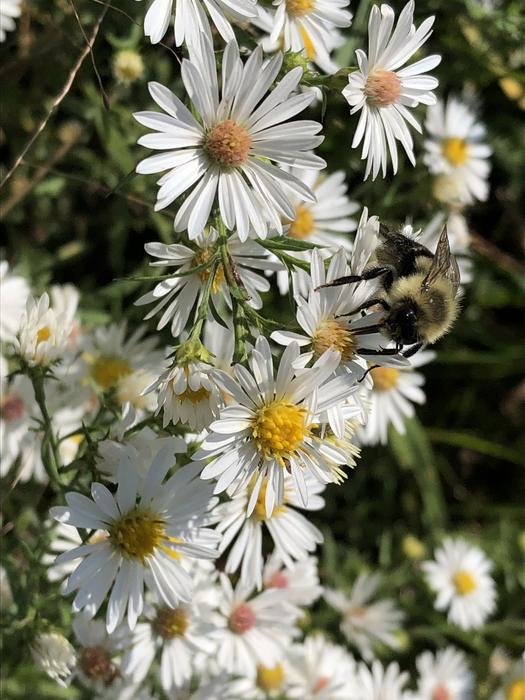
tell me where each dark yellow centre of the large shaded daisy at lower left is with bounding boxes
[109,507,168,564]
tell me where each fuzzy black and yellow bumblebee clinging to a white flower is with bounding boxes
[323,226,460,357]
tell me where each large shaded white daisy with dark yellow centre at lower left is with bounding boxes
[51,448,218,633]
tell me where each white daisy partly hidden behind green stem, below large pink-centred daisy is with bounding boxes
[135,228,284,337]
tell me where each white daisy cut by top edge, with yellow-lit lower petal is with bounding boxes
[270,0,352,73]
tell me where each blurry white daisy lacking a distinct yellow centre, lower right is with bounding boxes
[324,572,403,660]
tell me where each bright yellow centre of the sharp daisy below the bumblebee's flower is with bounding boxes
[252,400,310,466]
